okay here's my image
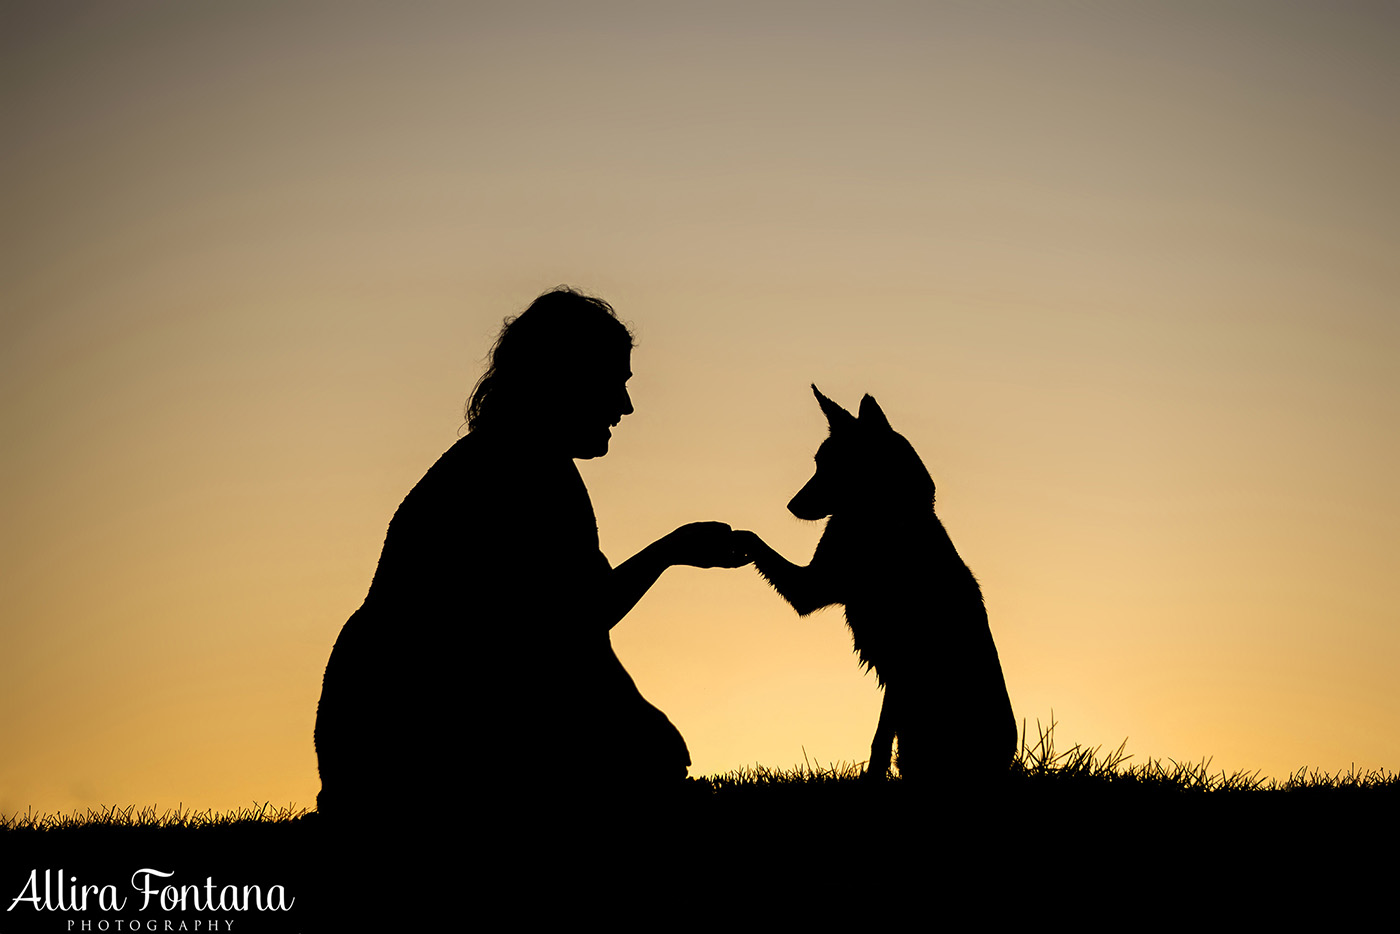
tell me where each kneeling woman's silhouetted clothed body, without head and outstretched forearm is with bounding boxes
[316,431,689,812]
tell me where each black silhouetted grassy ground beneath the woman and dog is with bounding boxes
[0,724,1400,934]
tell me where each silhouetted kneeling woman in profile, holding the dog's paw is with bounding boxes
[315,288,748,815]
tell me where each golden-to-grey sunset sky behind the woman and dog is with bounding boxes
[0,0,1400,814]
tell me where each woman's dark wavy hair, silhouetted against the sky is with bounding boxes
[466,286,634,431]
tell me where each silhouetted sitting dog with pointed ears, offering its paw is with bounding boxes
[743,385,1016,783]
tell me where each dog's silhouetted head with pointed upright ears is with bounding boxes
[788,385,934,520]
